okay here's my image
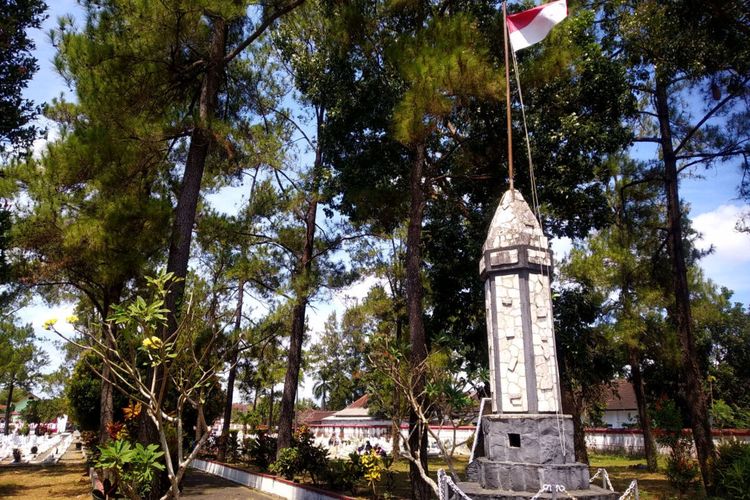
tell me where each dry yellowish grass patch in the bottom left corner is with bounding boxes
[0,464,91,500]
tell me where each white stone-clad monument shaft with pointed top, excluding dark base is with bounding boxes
[479,191,561,413]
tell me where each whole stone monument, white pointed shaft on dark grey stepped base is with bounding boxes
[459,188,617,500]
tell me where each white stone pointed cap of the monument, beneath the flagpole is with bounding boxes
[482,189,548,253]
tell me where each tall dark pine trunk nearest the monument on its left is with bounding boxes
[406,144,432,500]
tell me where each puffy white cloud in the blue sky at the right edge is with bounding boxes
[693,205,750,264]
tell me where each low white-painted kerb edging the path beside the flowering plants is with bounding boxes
[191,459,354,500]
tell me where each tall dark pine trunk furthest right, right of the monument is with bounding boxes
[654,72,715,493]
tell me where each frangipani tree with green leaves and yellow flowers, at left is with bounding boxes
[45,272,231,499]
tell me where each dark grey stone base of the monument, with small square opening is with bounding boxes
[470,413,616,499]
